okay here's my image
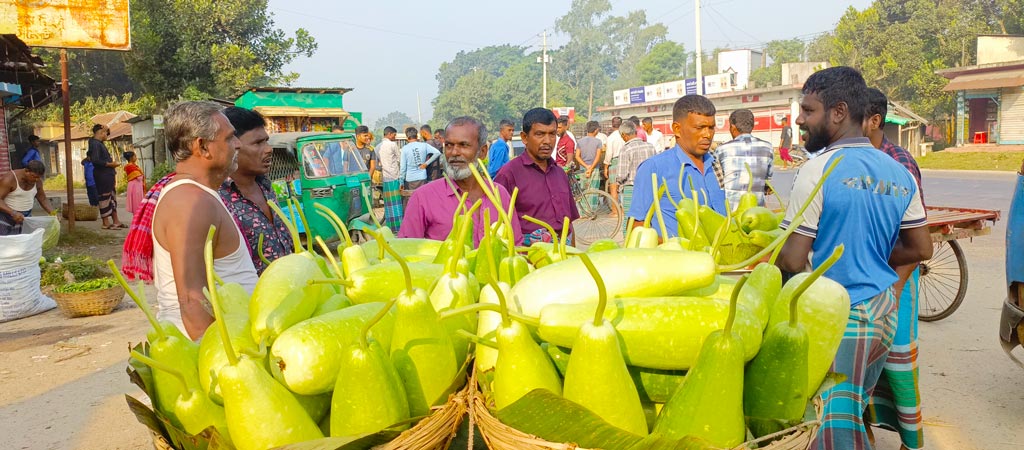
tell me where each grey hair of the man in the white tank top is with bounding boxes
[164,101,224,162]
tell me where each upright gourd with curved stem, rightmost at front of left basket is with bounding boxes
[382,237,459,416]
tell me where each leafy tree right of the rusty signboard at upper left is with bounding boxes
[126,0,316,103]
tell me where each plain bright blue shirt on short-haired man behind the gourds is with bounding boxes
[627,146,725,238]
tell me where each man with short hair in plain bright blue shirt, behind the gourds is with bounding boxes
[627,94,725,239]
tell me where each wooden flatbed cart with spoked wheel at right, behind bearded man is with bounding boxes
[918,206,999,322]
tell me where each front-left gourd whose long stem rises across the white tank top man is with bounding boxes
[204,227,324,450]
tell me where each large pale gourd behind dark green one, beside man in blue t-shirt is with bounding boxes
[768,246,850,395]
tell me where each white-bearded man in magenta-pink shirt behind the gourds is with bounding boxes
[398,117,523,247]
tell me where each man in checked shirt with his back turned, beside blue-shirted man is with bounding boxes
[716,110,775,209]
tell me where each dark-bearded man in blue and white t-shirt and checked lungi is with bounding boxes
[778,67,932,450]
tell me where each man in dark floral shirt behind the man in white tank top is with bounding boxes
[220,107,292,274]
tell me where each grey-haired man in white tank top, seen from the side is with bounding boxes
[153,101,257,339]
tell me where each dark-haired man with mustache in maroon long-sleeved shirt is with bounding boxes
[495,108,580,245]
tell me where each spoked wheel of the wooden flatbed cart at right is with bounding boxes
[918,241,968,322]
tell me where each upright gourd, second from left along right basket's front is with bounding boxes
[562,255,647,436]
